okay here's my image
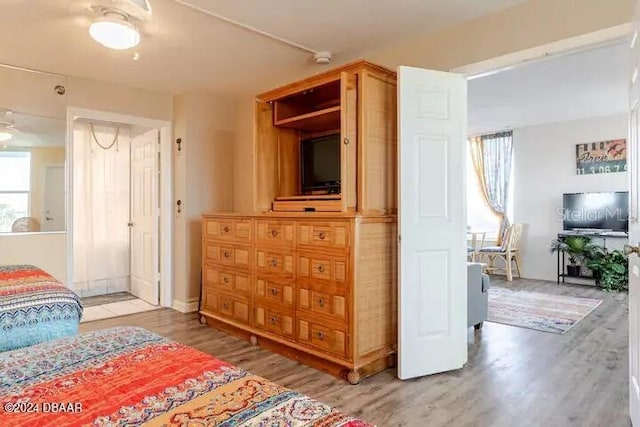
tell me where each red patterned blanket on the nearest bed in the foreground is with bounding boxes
[0,327,371,427]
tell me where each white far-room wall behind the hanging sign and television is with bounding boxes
[513,114,628,280]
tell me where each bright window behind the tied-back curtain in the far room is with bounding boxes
[467,144,515,240]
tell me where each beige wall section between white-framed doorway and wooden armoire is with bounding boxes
[173,92,236,311]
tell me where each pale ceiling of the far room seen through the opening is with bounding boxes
[468,42,631,135]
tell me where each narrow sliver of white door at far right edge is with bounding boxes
[627,1,640,427]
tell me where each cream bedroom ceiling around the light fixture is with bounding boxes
[0,0,525,94]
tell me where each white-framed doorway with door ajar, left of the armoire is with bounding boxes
[67,109,172,314]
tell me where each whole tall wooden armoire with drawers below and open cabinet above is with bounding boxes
[200,61,397,384]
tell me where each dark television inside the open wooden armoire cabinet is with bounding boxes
[300,134,340,194]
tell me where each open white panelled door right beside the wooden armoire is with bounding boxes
[398,67,467,379]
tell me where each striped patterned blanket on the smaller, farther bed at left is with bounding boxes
[0,265,82,351]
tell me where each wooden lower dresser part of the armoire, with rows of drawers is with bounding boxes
[200,213,396,384]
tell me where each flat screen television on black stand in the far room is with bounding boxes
[562,191,629,232]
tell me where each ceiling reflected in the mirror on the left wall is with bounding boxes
[0,112,66,148]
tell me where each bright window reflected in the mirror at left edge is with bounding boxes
[0,151,31,233]
